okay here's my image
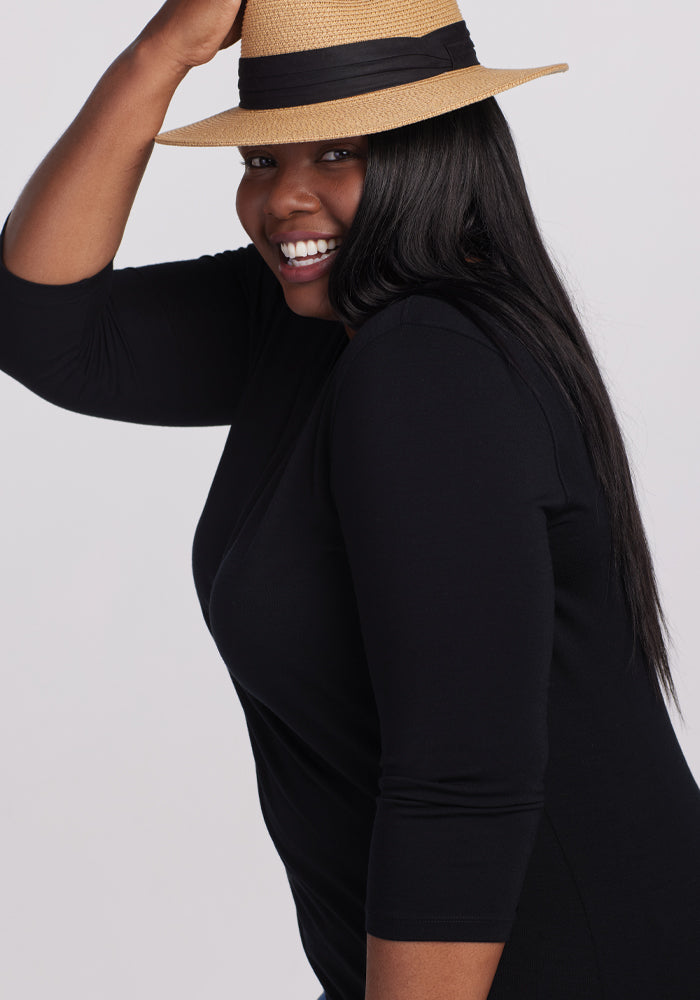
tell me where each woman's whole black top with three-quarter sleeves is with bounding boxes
[0,227,700,1000]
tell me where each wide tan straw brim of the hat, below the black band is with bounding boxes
[155,63,569,146]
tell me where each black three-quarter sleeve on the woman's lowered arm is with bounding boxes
[330,308,562,941]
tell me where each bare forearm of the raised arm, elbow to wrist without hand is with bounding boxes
[4,36,187,284]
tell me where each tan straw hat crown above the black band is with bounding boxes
[241,0,462,59]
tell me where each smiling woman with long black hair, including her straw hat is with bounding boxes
[0,0,700,1000]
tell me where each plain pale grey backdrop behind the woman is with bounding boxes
[0,0,700,1000]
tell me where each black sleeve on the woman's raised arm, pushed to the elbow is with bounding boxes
[0,217,264,426]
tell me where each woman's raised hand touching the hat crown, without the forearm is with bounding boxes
[135,0,243,72]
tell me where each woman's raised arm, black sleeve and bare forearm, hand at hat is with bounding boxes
[0,0,262,426]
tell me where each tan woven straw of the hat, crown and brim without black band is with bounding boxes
[156,0,569,146]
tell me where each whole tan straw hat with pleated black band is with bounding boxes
[156,0,569,146]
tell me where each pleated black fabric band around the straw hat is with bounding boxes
[238,21,479,110]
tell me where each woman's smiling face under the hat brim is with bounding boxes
[236,136,367,336]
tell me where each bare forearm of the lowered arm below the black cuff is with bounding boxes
[365,934,504,1000]
